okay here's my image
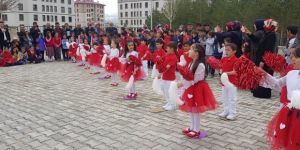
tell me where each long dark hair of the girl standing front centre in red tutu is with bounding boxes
[191,43,206,73]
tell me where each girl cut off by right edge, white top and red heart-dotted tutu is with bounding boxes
[261,47,300,150]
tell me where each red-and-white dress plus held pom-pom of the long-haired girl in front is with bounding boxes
[178,63,218,113]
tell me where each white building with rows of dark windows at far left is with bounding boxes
[2,0,75,26]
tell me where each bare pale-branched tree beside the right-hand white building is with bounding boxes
[161,0,179,29]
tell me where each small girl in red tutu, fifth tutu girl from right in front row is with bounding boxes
[88,43,103,75]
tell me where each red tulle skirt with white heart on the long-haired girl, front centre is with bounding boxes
[180,81,218,113]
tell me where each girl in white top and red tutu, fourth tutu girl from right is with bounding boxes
[105,40,120,86]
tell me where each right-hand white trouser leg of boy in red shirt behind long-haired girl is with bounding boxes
[228,87,237,116]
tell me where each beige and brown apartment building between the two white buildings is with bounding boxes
[75,0,105,27]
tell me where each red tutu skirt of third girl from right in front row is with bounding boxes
[120,63,144,82]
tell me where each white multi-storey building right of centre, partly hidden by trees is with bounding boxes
[118,0,165,30]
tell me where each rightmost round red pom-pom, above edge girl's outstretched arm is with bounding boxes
[263,52,286,73]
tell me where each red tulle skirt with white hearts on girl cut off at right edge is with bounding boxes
[267,106,300,150]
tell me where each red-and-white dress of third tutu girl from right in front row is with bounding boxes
[120,51,144,82]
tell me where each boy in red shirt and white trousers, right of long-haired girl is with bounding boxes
[219,43,238,120]
